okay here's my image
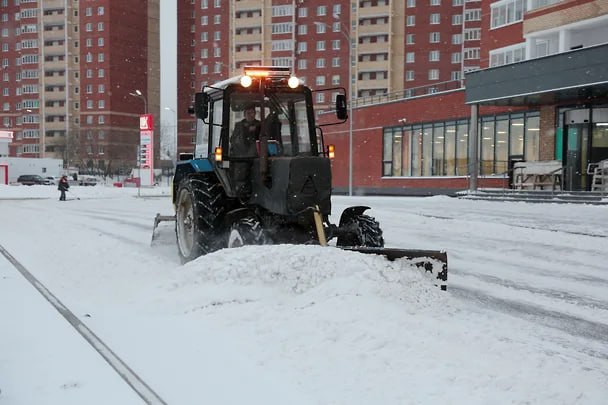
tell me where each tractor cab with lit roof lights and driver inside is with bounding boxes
[194,66,346,215]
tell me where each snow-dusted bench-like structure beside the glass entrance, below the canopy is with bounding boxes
[513,160,563,190]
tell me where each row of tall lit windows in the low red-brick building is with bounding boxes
[382,111,540,177]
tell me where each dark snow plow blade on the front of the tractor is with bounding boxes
[340,246,448,291]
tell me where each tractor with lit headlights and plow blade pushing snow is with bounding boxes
[155,66,447,288]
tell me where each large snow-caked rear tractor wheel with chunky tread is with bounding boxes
[175,176,226,263]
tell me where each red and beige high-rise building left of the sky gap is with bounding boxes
[0,0,160,171]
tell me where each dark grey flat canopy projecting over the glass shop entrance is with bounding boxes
[465,44,608,106]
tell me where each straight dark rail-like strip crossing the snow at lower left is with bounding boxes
[0,245,167,405]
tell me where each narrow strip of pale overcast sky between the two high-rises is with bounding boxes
[159,0,177,125]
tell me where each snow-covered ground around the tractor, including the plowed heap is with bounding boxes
[0,185,608,405]
